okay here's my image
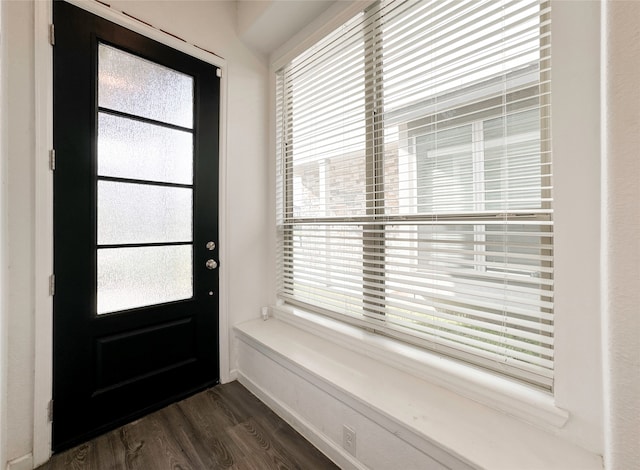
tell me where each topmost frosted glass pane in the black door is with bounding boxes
[98,44,193,129]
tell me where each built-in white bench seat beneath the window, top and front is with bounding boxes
[234,315,602,470]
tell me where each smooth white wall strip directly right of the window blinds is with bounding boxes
[551,1,604,455]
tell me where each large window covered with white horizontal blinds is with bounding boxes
[276,0,553,390]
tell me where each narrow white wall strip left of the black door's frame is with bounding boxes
[2,2,35,459]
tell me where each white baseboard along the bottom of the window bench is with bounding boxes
[237,371,367,470]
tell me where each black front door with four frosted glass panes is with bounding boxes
[53,2,220,451]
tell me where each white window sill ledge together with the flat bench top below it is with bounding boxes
[235,306,602,470]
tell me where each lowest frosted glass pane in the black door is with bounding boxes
[98,245,193,315]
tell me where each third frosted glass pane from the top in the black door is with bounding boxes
[98,181,193,245]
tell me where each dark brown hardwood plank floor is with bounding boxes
[38,382,338,470]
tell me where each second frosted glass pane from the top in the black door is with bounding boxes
[98,113,193,184]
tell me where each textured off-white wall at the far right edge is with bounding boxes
[602,1,640,470]
